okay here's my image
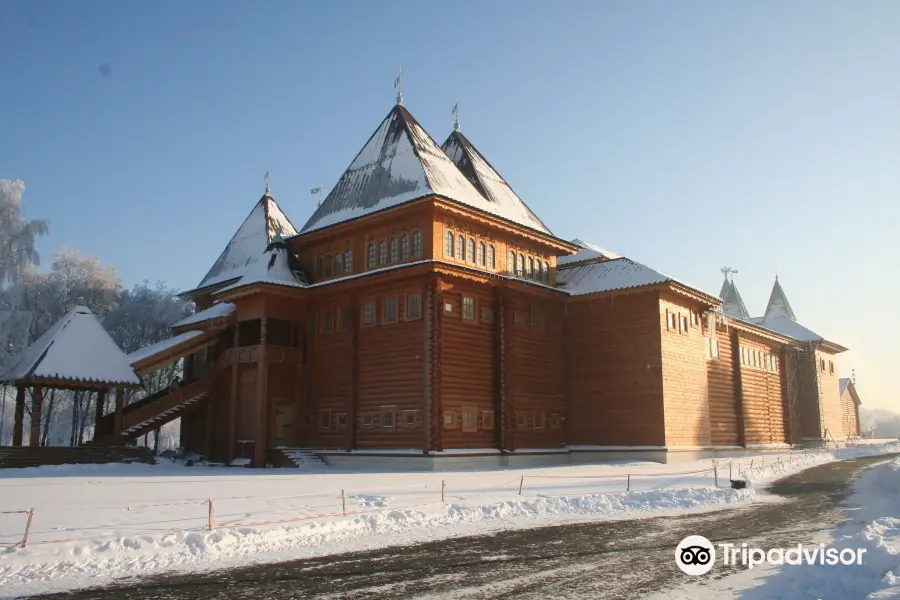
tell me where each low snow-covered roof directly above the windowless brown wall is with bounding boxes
[556,257,674,296]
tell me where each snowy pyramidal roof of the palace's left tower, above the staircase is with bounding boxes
[197,189,297,289]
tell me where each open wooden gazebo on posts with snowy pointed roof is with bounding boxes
[0,298,141,446]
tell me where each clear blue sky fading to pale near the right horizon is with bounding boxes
[0,0,900,407]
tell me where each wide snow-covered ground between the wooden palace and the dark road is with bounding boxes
[0,444,900,597]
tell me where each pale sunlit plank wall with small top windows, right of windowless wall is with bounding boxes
[658,297,710,447]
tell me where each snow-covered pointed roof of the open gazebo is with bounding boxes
[0,301,141,387]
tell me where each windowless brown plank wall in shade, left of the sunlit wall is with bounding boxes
[564,292,665,446]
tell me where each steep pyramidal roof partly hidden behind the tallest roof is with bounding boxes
[441,130,552,235]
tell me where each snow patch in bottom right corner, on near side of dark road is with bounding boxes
[659,446,900,600]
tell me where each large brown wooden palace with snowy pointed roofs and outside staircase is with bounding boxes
[8,103,858,469]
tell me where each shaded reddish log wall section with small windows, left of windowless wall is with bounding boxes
[495,290,567,448]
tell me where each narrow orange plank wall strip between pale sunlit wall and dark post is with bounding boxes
[701,319,740,446]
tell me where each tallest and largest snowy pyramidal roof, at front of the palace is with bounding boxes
[302,104,546,233]
